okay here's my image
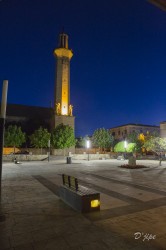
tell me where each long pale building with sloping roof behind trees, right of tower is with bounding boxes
[110,123,160,140]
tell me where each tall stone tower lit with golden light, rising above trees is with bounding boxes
[54,33,75,129]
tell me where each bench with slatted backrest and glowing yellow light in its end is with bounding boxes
[59,174,100,213]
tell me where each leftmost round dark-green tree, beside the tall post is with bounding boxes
[4,125,26,154]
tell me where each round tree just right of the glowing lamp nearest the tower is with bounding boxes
[92,128,114,152]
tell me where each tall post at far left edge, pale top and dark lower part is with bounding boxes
[0,80,8,197]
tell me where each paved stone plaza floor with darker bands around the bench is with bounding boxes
[0,158,166,250]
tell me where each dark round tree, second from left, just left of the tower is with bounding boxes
[29,127,51,154]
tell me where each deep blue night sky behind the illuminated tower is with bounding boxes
[0,0,166,136]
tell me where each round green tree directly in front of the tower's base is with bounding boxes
[51,123,76,149]
